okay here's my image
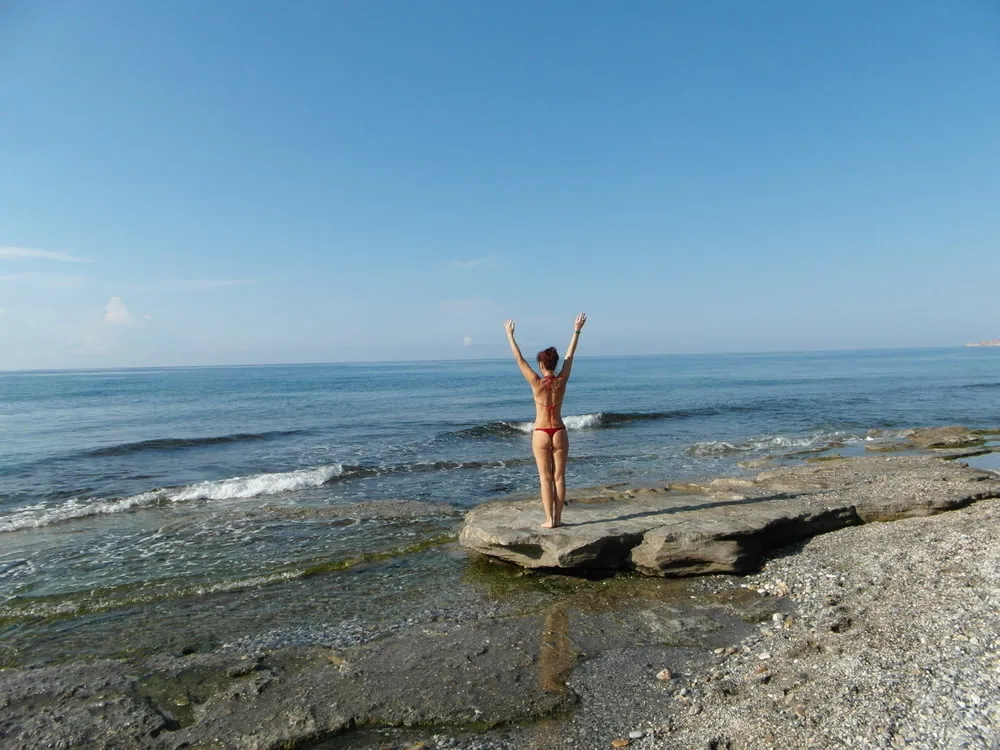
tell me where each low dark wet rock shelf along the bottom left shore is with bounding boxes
[0,615,576,750]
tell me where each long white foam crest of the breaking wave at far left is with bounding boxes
[0,464,344,533]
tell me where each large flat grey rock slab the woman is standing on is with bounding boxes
[459,456,1000,576]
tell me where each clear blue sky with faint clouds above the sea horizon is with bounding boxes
[0,0,1000,369]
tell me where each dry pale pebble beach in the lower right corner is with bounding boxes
[648,488,1000,748]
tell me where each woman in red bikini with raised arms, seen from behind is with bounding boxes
[504,313,587,529]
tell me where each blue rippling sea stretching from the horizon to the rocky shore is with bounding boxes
[0,347,1000,666]
